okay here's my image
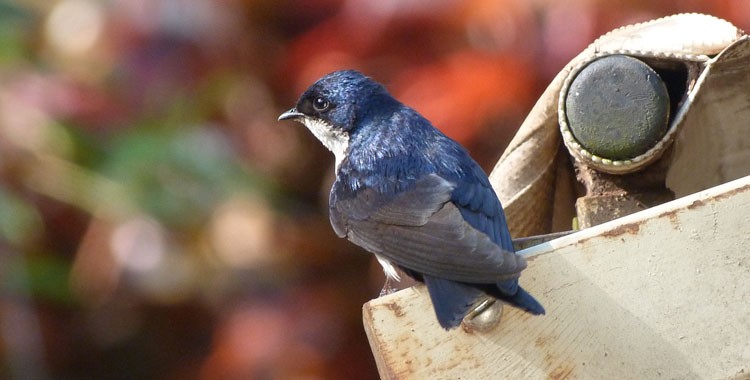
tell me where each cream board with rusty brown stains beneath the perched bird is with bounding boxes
[363,177,750,379]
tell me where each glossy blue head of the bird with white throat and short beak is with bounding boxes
[279,70,392,166]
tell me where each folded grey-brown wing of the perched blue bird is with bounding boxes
[330,174,526,284]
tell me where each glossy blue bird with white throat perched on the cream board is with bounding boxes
[279,70,545,330]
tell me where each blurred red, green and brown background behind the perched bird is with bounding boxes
[0,0,750,380]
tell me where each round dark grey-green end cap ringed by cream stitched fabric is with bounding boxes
[564,55,670,161]
